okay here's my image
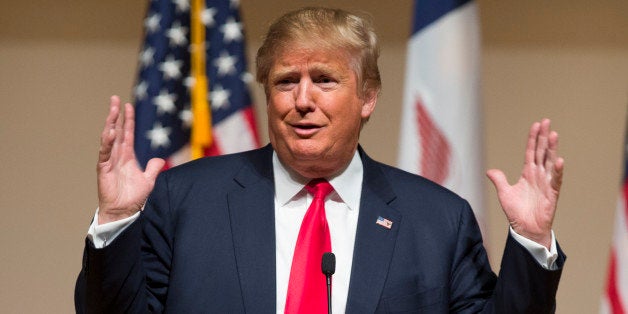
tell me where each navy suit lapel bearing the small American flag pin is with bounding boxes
[346,148,401,313]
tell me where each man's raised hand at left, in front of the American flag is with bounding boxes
[96,96,165,224]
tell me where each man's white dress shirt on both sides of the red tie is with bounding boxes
[273,152,363,313]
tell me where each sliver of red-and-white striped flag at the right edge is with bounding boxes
[600,125,628,314]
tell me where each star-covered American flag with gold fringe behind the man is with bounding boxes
[134,0,259,167]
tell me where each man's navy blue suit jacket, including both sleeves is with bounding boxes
[75,146,565,313]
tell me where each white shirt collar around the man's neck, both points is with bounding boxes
[273,151,364,210]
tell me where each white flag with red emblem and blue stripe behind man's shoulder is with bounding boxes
[399,0,486,236]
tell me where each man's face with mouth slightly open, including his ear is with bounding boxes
[267,45,377,178]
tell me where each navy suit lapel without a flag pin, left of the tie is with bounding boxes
[228,146,276,313]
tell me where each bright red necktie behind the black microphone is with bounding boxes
[285,179,334,314]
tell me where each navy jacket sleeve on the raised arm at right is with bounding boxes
[450,200,565,314]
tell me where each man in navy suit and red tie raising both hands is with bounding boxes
[75,8,565,313]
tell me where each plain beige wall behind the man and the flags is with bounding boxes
[0,0,628,313]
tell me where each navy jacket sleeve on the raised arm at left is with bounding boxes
[74,175,173,313]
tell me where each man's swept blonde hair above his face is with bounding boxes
[255,7,382,96]
